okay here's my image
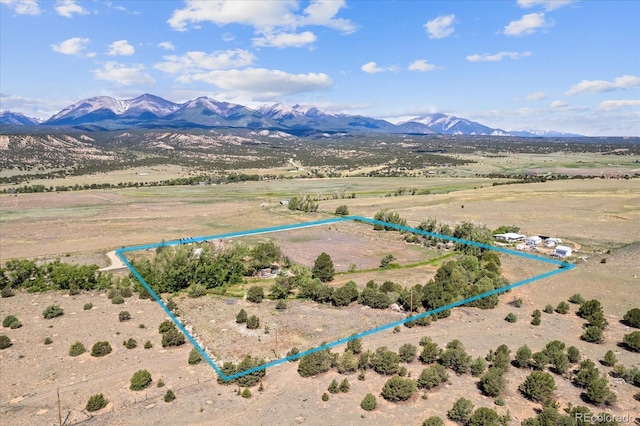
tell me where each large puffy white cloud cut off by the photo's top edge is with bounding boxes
[167,0,356,33]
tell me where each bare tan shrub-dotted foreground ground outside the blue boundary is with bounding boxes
[0,241,640,425]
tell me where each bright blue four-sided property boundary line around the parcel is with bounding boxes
[115,216,575,381]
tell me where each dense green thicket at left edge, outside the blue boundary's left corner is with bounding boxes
[0,259,111,297]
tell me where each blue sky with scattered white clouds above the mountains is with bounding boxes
[0,0,640,136]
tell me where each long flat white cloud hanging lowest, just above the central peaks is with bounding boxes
[188,68,333,99]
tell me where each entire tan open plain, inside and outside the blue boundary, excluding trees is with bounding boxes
[0,148,640,425]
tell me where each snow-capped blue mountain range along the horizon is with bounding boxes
[0,93,581,137]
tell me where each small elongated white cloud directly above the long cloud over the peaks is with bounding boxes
[154,49,255,74]
